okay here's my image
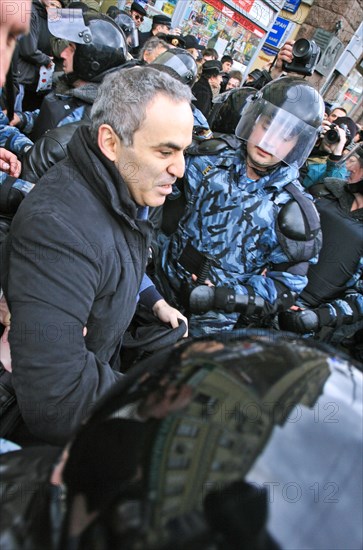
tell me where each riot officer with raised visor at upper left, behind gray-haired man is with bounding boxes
[9,9,127,141]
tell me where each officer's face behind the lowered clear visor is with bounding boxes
[247,115,298,169]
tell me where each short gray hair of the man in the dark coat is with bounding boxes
[91,67,192,147]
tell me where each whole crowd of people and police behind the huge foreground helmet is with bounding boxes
[0,0,363,445]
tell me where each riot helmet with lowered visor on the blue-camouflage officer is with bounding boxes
[236,77,325,167]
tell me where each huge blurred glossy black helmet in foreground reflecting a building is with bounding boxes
[60,330,363,550]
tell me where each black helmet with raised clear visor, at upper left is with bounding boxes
[48,9,127,82]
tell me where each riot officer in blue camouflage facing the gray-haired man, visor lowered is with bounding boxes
[161,78,324,334]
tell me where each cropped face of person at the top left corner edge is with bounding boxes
[0,0,31,88]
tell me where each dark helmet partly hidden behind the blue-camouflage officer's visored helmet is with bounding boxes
[208,86,256,134]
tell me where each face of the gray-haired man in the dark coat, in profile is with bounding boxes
[116,94,193,206]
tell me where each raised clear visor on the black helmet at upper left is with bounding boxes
[48,8,92,44]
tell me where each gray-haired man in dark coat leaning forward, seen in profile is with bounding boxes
[3,67,193,445]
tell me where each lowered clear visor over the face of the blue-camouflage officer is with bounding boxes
[236,98,318,167]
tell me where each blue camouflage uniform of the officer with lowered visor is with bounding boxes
[162,148,320,335]
